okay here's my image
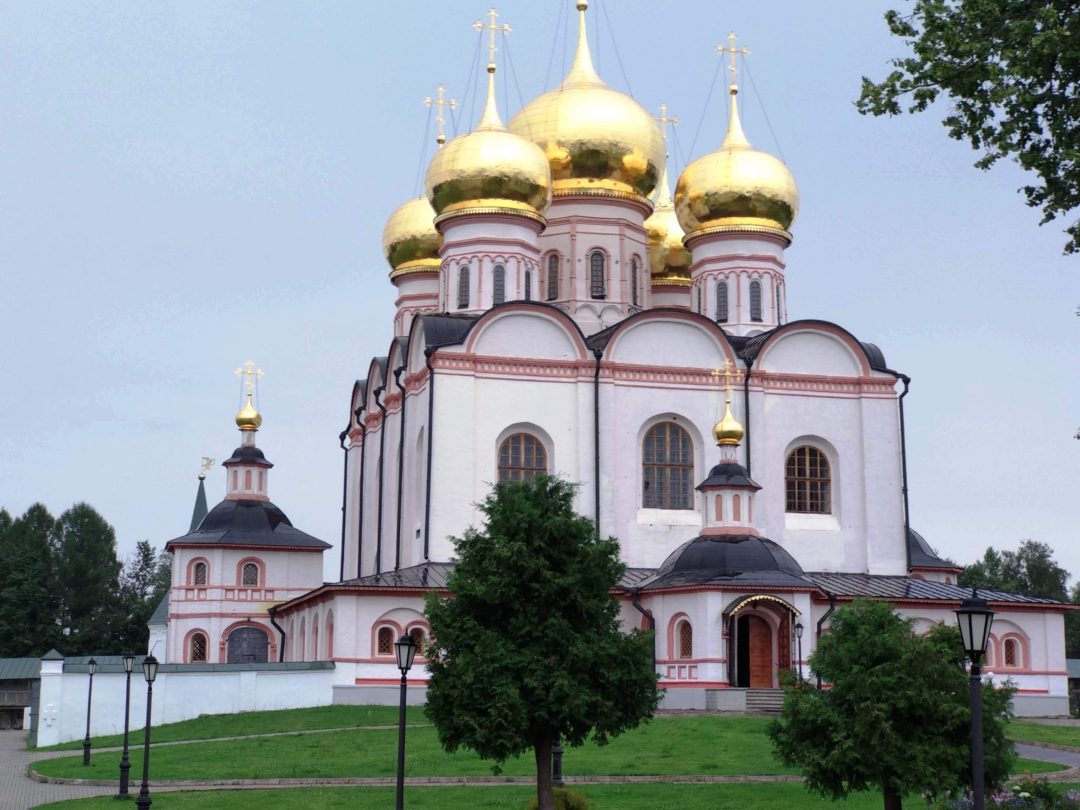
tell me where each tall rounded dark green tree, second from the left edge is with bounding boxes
[53,503,123,654]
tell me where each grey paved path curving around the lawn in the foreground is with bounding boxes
[8,729,1080,810]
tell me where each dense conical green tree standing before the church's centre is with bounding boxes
[427,476,658,810]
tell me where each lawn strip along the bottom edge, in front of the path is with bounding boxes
[31,783,937,810]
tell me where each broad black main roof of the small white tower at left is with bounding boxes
[165,499,330,549]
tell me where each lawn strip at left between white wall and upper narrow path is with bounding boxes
[39,706,428,751]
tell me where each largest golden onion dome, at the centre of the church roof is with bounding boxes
[510,0,664,203]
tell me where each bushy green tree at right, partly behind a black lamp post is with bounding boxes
[769,599,1012,810]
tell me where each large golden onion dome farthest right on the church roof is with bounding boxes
[675,84,799,240]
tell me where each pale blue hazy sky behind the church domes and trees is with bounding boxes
[0,0,1080,579]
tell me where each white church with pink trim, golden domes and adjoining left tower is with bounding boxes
[154,0,1067,715]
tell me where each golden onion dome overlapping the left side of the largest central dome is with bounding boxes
[424,64,551,218]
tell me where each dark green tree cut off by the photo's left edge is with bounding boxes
[0,503,59,657]
